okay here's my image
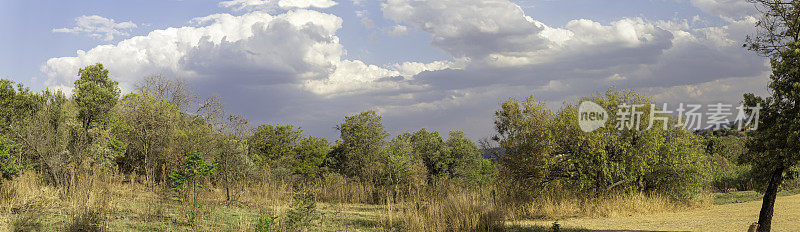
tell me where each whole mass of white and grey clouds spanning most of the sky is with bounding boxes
[42,0,766,138]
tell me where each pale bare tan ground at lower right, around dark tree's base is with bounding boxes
[514,194,800,231]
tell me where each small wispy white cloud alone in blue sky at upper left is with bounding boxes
[53,15,136,41]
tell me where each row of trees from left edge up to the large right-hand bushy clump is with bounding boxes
[0,64,495,198]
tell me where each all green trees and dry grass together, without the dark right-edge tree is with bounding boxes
[0,51,797,231]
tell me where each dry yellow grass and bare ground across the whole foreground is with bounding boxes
[0,170,800,232]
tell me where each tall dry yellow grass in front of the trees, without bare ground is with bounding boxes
[0,171,712,232]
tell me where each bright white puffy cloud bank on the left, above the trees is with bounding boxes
[41,9,450,96]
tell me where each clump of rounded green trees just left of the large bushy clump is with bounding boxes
[326,111,494,185]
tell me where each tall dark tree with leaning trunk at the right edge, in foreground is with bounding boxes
[742,0,800,232]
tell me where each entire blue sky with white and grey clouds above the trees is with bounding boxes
[0,0,769,139]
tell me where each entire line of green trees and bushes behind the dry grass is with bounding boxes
[0,64,788,205]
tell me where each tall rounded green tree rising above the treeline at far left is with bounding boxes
[73,63,120,130]
